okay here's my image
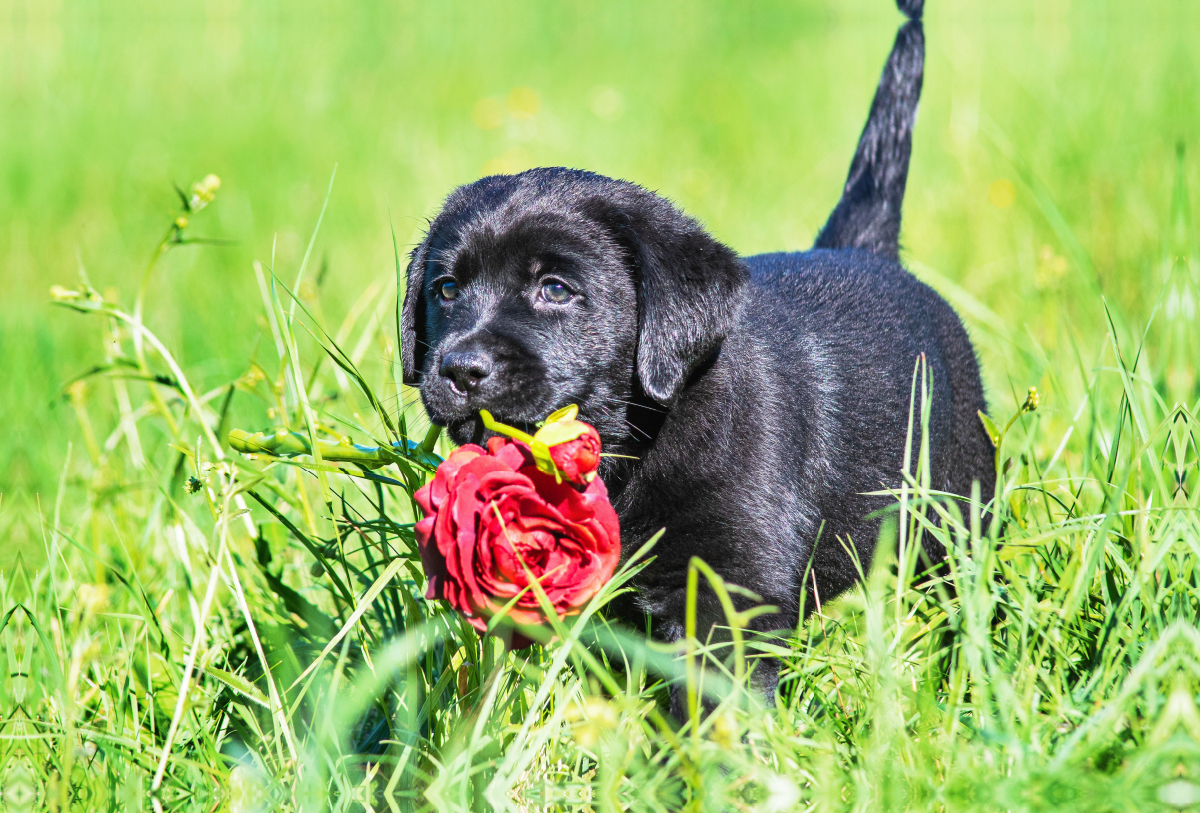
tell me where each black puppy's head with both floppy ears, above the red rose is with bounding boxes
[401,169,746,444]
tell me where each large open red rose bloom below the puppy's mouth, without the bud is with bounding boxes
[415,438,620,632]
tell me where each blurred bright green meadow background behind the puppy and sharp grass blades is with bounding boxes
[0,0,1200,564]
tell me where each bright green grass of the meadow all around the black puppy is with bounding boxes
[0,4,1200,811]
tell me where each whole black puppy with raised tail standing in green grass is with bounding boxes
[401,0,994,688]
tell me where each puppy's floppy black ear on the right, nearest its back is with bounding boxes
[595,193,750,404]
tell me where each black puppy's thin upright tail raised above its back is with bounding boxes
[814,0,925,259]
